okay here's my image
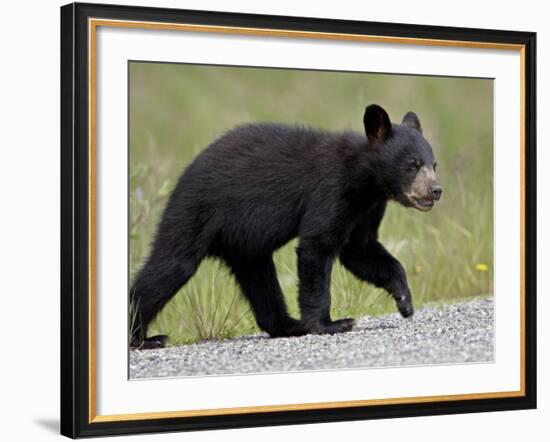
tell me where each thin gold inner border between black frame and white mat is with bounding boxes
[88,18,525,423]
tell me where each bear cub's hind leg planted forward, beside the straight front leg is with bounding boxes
[227,256,305,338]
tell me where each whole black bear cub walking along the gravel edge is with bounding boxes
[130,104,442,348]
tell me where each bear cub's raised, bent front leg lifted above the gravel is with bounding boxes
[340,239,414,318]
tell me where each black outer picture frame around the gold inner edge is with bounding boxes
[61,3,537,438]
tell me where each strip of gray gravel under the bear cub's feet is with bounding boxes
[130,299,494,379]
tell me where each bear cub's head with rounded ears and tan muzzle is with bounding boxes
[363,104,443,212]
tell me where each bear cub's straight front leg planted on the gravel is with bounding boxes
[297,240,355,334]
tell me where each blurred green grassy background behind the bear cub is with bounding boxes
[129,62,493,344]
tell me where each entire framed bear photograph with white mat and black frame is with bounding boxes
[61,4,536,438]
